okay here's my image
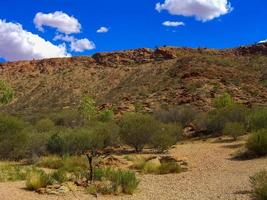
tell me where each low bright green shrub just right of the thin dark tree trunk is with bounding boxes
[94,168,139,194]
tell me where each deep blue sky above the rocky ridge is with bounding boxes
[0,0,267,60]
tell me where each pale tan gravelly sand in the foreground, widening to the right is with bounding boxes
[0,139,267,200]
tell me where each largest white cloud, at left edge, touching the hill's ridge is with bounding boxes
[0,19,70,61]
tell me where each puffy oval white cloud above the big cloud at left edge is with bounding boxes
[33,11,81,34]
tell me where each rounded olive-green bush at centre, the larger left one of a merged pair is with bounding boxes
[120,113,159,152]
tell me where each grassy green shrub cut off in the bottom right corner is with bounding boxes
[250,170,267,200]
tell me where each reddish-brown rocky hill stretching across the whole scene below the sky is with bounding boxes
[0,43,267,113]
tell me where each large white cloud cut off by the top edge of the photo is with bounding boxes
[156,0,233,22]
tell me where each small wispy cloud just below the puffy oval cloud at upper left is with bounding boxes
[54,34,96,52]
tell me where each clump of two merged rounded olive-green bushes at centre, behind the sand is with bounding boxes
[120,113,182,152]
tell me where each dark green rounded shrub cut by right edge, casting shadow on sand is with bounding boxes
[246,129,267,156]
